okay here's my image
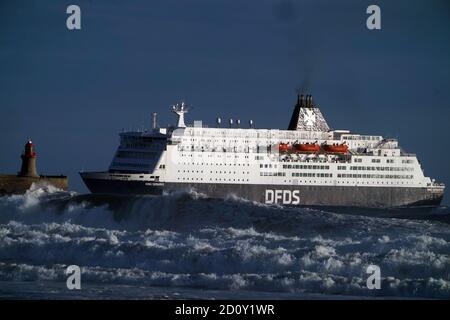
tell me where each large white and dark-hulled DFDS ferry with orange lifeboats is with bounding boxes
[80,95,445,208]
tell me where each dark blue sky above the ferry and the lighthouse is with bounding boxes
[0,0,450,200]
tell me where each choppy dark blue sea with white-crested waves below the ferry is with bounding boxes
[0,186,450,299]
